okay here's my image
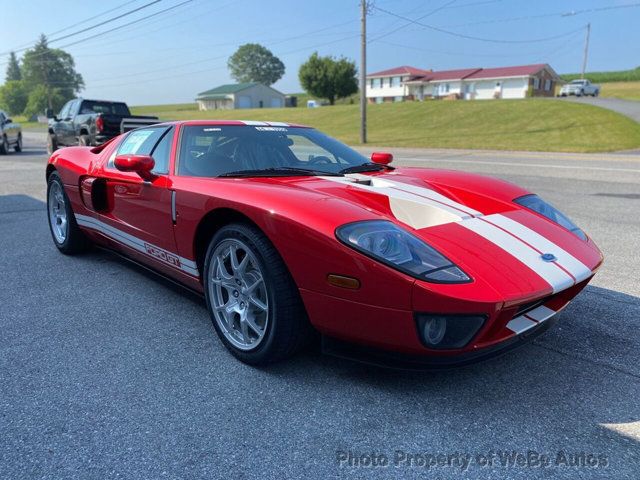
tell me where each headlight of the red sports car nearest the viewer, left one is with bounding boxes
[336,220,471,283]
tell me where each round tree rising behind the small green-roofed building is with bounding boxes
[227,43,285,86]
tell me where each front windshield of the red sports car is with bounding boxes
[178,125,372,177]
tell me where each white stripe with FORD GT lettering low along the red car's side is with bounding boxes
[76,214,199,277]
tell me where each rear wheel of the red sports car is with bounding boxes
[47,172,91,255]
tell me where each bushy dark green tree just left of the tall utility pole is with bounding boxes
[298,52,358,105]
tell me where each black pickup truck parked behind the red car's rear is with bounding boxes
[47,98,159,154]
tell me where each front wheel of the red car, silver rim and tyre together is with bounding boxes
[204,224,312,365]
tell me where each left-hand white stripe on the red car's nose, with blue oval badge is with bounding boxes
[460,218,574,292]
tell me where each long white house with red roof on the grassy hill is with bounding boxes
[367,64,562,103]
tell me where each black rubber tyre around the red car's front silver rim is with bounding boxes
[204,223,313,365]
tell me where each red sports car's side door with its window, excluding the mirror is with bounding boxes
[91,126,181,269]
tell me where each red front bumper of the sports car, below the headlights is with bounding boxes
[301,279,590,369]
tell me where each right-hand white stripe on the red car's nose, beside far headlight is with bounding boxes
[482,214,592,283]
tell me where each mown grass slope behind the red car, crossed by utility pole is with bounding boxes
[132,99,640,152]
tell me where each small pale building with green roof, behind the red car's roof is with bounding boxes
[196,83,285,110]
